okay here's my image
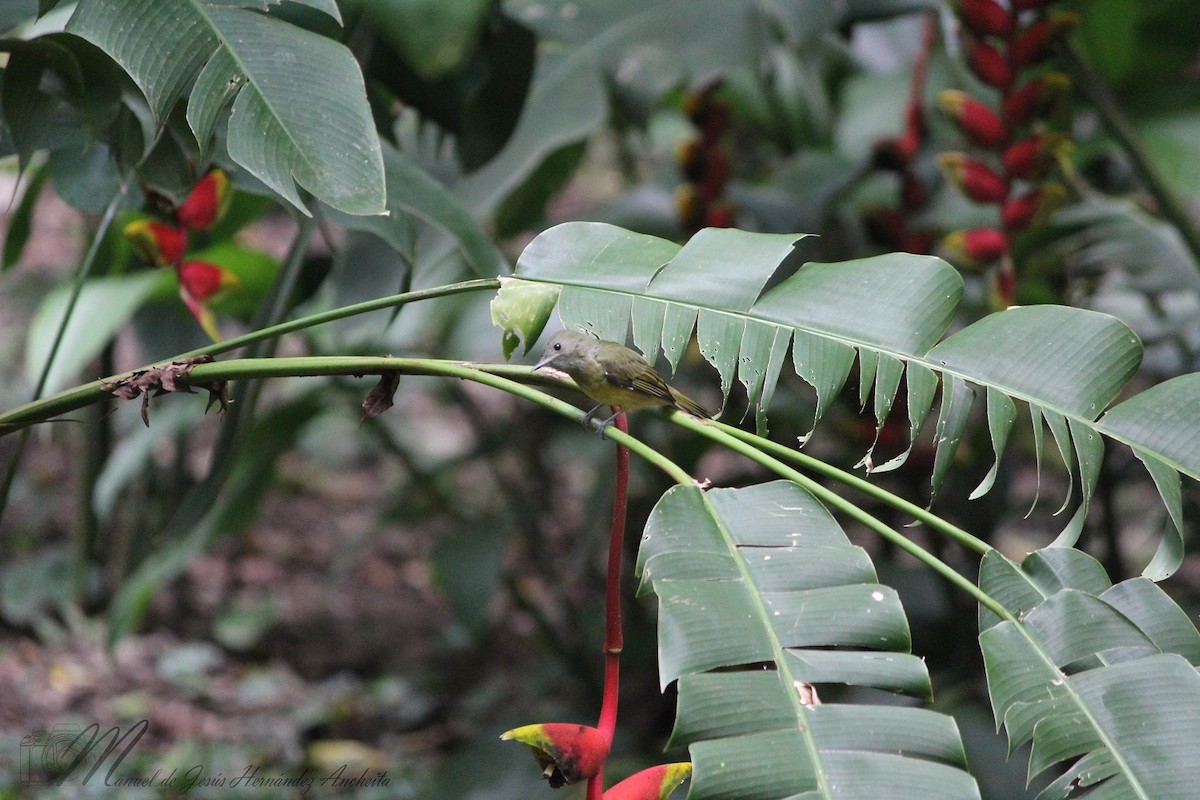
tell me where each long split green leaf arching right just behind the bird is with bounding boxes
[493,222,1200,579]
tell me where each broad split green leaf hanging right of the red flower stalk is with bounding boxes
[638,481,979,800]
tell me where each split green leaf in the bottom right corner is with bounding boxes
[979,547,1200,800]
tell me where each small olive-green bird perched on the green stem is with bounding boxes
[533,330,713,426]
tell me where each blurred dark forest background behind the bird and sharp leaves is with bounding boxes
[0,0,1200,800]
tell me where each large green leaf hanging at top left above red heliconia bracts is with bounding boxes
[67,0,384,213]
